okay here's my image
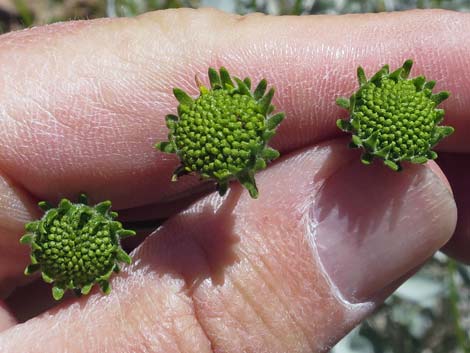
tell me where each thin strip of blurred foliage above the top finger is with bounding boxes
[0,0,470,32]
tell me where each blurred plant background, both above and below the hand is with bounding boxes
[0,0,470,353]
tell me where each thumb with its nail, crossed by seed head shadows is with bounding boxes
[0,140,456,352]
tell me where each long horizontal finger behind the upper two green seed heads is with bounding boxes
[0,10,470,212]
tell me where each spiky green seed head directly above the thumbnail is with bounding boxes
[337,60,454,171]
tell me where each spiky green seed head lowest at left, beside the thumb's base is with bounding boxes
[20,195,135,300]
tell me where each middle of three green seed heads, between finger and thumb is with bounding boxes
[155,67,284,198]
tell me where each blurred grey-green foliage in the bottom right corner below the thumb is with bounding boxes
[331,253,470,353]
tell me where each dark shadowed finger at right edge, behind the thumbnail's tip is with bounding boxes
[438,153,470,263]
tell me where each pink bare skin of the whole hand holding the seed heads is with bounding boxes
[0,10,470,352]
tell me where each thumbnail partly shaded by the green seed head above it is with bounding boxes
[310,163,456,303]
